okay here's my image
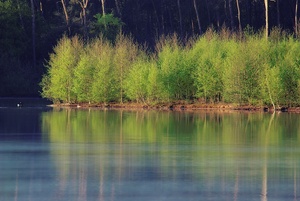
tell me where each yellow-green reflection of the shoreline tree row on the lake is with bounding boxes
[42,110,300,200]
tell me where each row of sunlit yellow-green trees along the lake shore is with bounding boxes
[41,29,300,107]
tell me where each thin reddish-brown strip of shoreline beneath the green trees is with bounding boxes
[48,102,300,113]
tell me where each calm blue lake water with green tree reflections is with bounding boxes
[0,101,300,201]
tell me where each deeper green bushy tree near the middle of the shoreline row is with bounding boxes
[157,35,194,101]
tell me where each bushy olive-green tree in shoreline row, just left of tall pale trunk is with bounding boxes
[224,38,264,105]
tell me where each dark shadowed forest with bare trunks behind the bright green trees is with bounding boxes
[0,0,299,96]
